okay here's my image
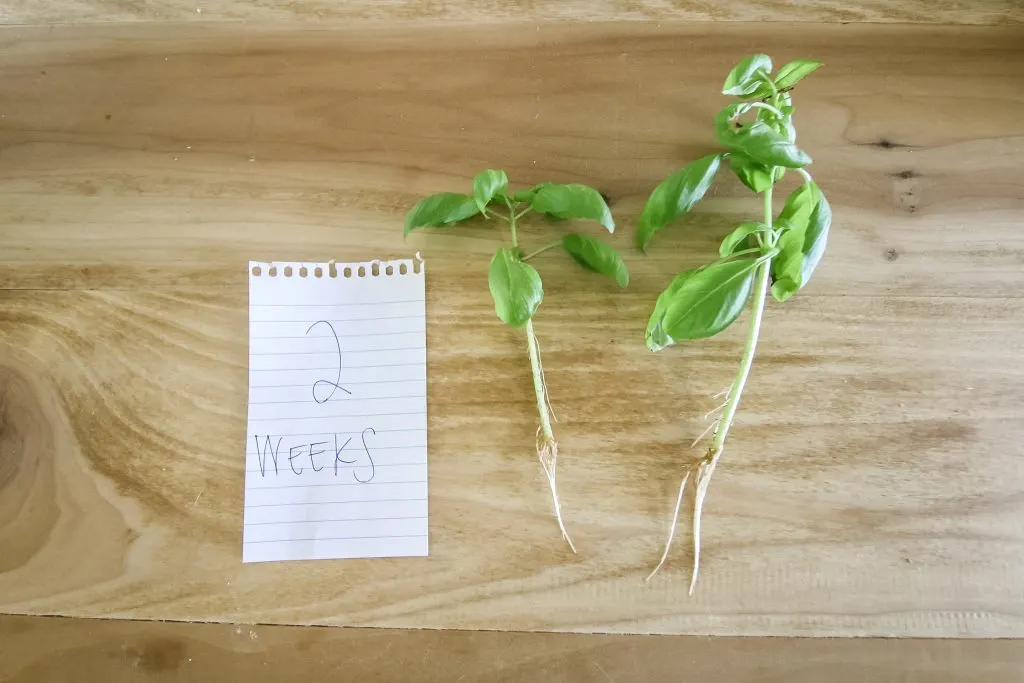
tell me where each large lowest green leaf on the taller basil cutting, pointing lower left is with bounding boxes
[655,259,761,344]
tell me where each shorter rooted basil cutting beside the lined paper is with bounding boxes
[406,170,630,552]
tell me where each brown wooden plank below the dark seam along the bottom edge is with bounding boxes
[0,616,1024,683]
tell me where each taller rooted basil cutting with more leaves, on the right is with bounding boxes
[637,54,831,593]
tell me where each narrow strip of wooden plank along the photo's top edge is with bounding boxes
[0,0,1024,29]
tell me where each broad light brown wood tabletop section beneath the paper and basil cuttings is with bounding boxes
[0,25,1024,637]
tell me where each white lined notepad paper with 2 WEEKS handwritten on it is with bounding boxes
[242,260,427,562]
